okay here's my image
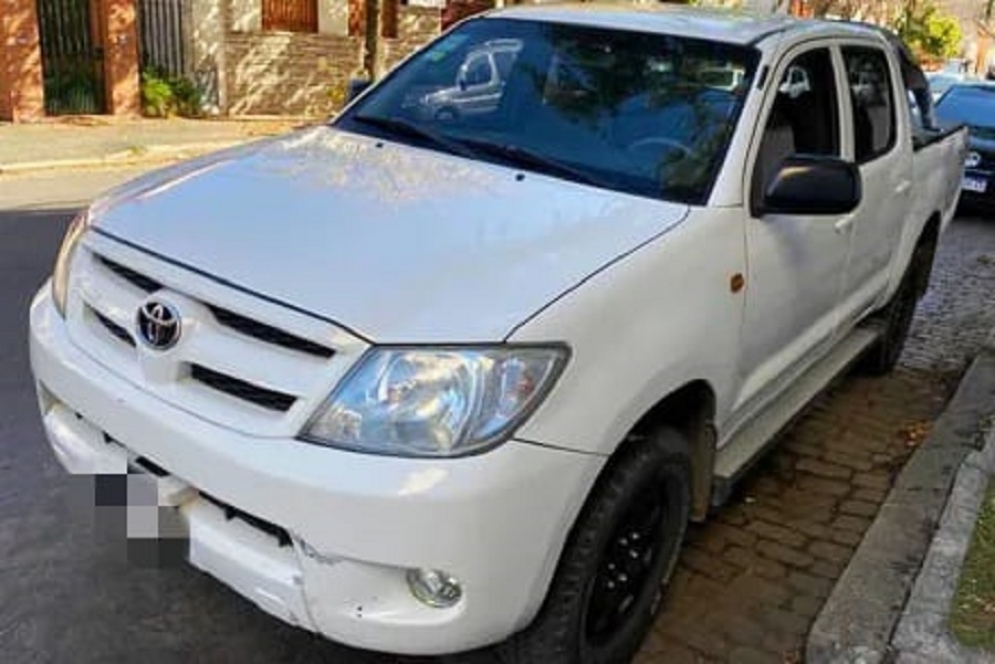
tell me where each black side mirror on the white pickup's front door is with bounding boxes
[763,155,862,215]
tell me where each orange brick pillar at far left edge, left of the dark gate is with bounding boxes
[0,0,45,122]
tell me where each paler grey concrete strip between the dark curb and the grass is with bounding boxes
[892,431,995,664]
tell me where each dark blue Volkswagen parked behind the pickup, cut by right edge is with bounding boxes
[936,83,995,209]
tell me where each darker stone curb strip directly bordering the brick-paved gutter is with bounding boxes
[805,333,995,664]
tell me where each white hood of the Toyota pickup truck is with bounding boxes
[92,127,688,343]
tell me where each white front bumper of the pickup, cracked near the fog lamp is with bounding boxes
[31,286,603,654]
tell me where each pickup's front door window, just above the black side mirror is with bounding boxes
[750,48,840,212]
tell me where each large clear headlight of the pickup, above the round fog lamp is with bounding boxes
[301,346,567,457]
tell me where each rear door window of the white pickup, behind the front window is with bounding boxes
[843,46,895,164]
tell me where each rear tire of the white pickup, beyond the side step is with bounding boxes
[860,237,935,376]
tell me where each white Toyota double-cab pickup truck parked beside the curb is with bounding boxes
[30,5,965,664]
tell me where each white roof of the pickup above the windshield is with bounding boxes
[487,2,888,45]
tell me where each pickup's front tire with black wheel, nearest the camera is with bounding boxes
[499,428,691,664]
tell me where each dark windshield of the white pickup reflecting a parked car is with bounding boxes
[335,18,758,203]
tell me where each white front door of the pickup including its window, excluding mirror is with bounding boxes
[732,45,852,427]
